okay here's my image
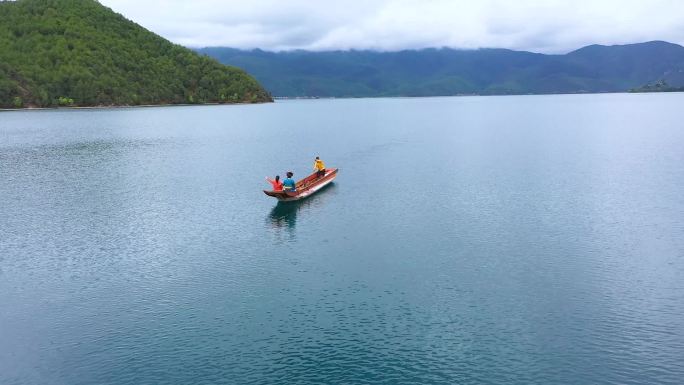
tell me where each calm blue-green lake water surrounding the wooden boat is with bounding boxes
[0,94,684,385]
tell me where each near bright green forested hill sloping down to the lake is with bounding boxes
[0,0,271,107]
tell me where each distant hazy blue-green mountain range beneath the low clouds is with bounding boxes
[198,41,684,97]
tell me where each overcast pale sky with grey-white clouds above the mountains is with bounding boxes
[100,0,684,53]
